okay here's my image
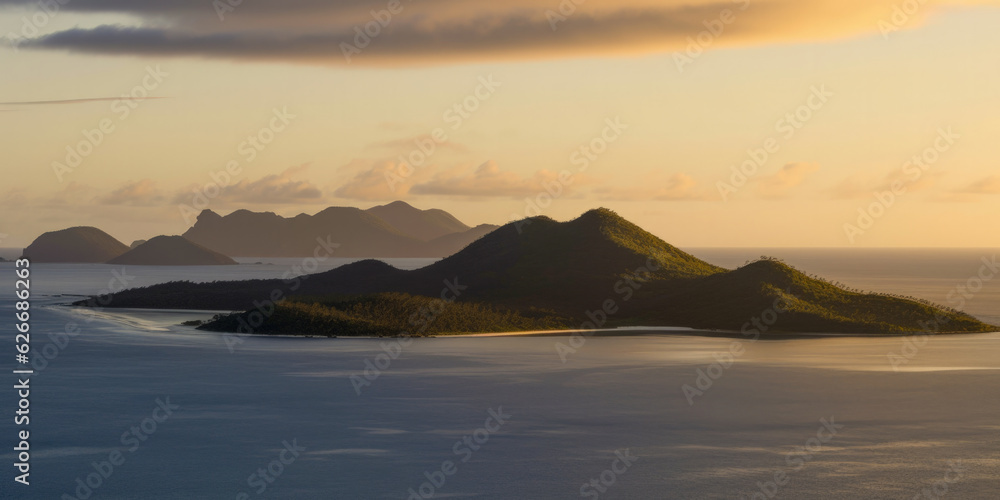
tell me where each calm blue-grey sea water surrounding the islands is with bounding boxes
[0,250,1000,499]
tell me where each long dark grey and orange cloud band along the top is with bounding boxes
[0,0,995,65]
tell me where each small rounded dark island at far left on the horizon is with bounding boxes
[24,227,128,263]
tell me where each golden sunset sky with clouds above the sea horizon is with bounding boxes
[0,0,1000,248]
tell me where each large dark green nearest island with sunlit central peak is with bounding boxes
[76,209,997,336]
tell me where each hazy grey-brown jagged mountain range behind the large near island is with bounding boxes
[184,203,490,258]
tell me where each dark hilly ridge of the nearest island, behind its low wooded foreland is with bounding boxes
[78,209,996,334]
